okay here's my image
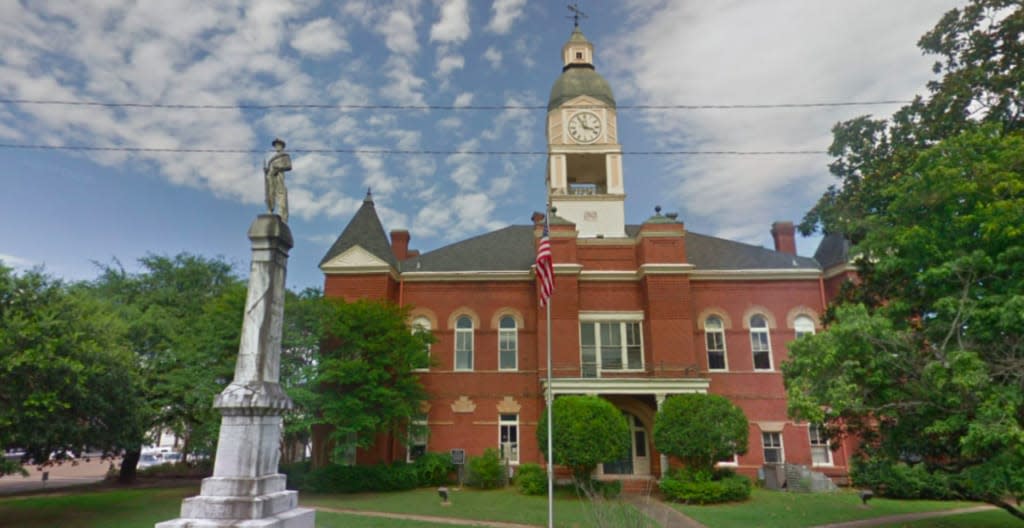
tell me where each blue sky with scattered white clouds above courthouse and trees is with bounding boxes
[0,0,964,290]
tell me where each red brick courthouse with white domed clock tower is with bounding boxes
[314,29,851,480]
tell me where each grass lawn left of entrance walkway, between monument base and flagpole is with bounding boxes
[301,488,606,528]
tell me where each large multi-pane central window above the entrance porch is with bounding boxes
[580,321,643,378]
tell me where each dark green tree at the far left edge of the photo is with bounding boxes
[0,264,141,474]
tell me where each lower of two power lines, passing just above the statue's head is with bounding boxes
[0,143,828,156]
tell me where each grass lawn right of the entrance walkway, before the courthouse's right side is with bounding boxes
[673,489,977,528]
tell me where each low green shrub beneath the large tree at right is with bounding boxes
[850,457,955,500]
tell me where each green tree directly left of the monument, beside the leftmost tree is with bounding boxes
[88,254,246,482]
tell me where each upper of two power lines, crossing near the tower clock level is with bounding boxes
[0,98,911,111]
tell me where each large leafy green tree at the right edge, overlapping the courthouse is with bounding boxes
[783,0,1024,520]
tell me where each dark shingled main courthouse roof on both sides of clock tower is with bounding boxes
[401,225,820,271]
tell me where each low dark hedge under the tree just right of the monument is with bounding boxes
[302,463,420,493]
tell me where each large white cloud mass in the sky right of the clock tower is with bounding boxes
[597,0,958,244]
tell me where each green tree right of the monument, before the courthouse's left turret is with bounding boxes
[307,298,433,460]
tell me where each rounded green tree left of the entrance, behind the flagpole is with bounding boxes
[537,396,630,484]
